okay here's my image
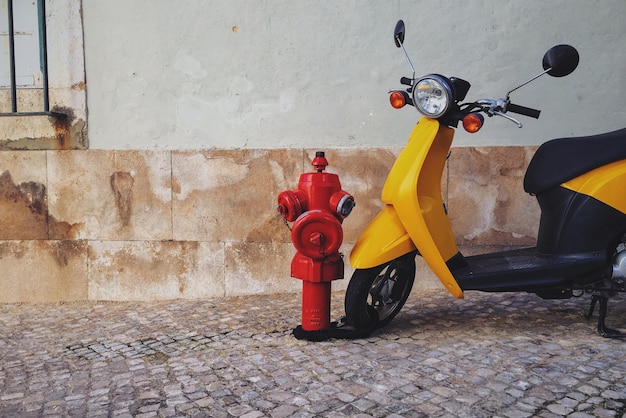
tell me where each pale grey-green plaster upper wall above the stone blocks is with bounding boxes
[82,0,626,149]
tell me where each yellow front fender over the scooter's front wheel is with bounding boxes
[350,205,416,269]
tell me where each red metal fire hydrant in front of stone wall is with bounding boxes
[278,151,355,339]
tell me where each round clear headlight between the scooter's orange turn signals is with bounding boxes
[413,74,454,118]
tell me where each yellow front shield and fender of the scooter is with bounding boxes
[350,118,463,298]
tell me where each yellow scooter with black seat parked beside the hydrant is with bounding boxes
[345,21,626,337]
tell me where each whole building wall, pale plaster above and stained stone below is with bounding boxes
[0,0,626,302]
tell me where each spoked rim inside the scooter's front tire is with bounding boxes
[367,263,407,321]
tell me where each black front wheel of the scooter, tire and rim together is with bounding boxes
[345,251,417,330]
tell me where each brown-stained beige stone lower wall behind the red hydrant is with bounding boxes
[0,147,538,302]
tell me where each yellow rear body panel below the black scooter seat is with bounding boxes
[562,160,626,213]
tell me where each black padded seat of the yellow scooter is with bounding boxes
[524,128,626,194]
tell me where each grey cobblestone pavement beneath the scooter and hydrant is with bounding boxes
[0,292,626,418]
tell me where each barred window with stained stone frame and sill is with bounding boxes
[0,0,87,150]
